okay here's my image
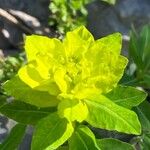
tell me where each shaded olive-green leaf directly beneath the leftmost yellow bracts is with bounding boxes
[3,76,58,107]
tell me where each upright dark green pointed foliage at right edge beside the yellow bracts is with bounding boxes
[124,25,150,88]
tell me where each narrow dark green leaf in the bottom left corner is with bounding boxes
[0,124,26,150]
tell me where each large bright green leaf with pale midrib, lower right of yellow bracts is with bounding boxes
[85,95,141,135]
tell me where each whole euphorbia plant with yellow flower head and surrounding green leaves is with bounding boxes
[0,26,146,150]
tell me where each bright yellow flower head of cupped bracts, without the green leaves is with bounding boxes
[18,26,127,122]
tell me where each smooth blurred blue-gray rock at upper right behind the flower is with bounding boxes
[88,0,150,38]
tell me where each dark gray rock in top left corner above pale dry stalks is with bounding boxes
[0,0,50,24]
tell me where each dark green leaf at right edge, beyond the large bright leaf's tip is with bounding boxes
[134,101,150,132]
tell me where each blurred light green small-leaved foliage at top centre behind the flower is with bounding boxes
[49,0,116,34]
